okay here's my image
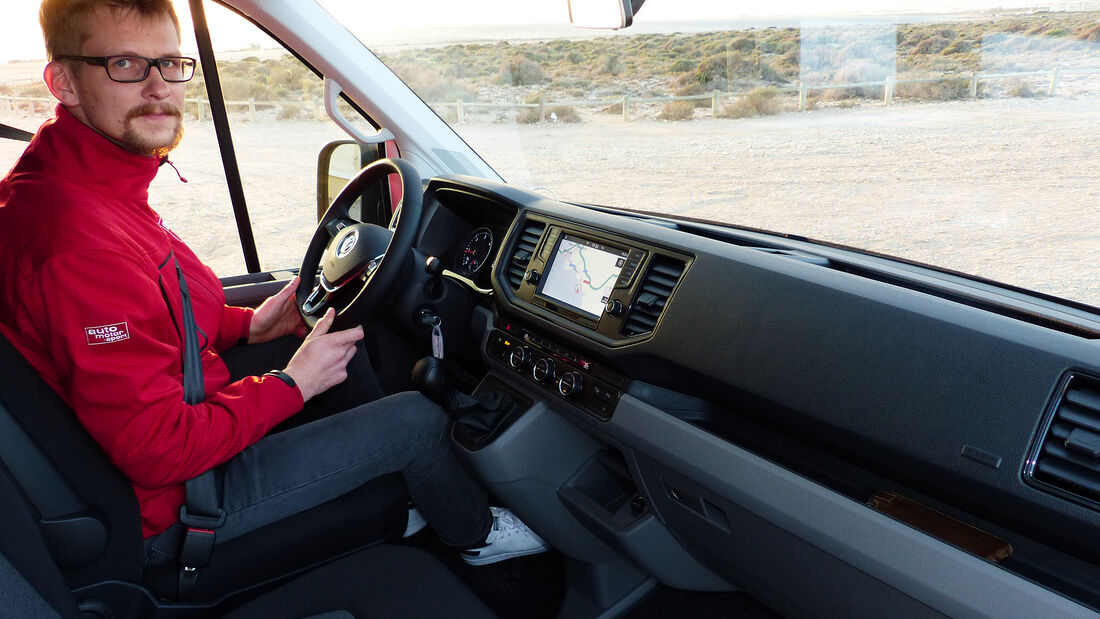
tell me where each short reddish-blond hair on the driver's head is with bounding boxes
[39,0,179,60]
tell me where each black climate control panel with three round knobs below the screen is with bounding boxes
[485,323,624,421]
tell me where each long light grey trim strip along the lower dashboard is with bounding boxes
[602,395,1100,619]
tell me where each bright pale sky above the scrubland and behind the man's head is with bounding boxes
[0,0,1100,63]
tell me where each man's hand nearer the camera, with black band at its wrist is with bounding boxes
[273,307,363,401]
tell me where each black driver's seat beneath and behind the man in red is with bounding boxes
[0,336,408,601]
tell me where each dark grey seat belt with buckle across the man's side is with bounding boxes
[172,255,226,601]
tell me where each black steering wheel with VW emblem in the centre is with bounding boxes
[295,158,424,331]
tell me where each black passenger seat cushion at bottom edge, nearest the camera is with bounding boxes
[226,544,495,619]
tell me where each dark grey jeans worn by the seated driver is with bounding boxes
[145,340,492,566]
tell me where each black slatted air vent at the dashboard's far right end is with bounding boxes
[1029,375,1100,509]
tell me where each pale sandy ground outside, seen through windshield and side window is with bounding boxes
[0,97,1100,306]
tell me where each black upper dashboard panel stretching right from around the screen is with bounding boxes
[422,177,1100,605]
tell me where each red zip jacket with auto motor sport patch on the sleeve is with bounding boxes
[0,106,303,538]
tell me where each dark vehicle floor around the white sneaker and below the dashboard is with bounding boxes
[404,528,781,619]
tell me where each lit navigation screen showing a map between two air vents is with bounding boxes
[538,234,628,318]
